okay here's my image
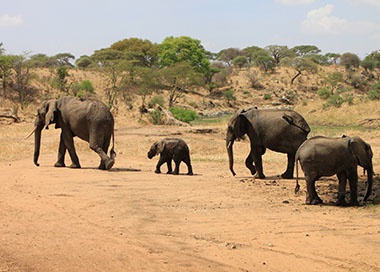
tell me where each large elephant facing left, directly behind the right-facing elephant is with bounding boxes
[226,107,310,179]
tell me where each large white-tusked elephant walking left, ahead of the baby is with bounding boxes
[33,97,116,170]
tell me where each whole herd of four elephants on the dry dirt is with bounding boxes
[31,97,373,205]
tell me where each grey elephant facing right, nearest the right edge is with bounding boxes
[295,136,373,206]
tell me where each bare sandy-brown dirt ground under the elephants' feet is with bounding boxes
[0,124,380,272]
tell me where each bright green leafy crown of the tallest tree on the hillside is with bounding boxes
[159,36,210,76]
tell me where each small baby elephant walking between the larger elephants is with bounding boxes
[148,138,193,175]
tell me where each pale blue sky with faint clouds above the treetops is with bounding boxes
[0,0,380,58]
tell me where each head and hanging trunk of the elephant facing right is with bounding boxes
[348,137,373,201]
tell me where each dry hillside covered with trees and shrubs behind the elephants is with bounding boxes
[0,36,380,127]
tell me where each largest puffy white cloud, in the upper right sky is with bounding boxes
[302,4,377,34]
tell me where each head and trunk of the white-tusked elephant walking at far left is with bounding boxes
[32,100,57,166]
